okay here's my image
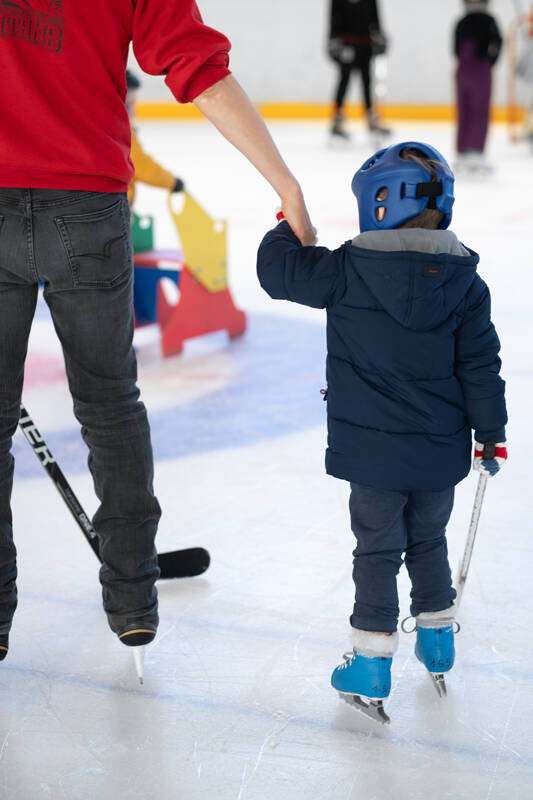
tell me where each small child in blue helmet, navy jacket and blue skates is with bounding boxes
[257,142,507,721]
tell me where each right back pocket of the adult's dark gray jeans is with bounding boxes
[54,195,132,288]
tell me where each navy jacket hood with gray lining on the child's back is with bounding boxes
[346,228,479,331]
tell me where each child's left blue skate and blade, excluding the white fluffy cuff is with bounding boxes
[331,648,392,723]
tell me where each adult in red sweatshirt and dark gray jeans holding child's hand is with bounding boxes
[0,0,315,660]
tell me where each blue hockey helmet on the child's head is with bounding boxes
[352,142,455,232]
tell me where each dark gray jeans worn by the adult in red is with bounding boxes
[0,188,161,633]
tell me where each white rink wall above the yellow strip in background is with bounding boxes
[130,0,529,104]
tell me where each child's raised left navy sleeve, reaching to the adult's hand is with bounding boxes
[257,222,346,308]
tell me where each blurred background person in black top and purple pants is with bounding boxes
[453,0,502,174]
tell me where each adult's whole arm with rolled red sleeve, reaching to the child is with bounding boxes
[132,0,316,244]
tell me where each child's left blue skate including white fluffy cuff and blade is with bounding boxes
[331,628,398,723]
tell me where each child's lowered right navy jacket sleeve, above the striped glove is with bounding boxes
[455,277,507,444]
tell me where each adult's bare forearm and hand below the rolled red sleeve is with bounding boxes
[193,75,316,245]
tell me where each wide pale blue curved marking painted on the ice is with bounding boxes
[15,304,326,478]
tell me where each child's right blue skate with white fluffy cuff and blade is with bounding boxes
[402,605,459,697]
